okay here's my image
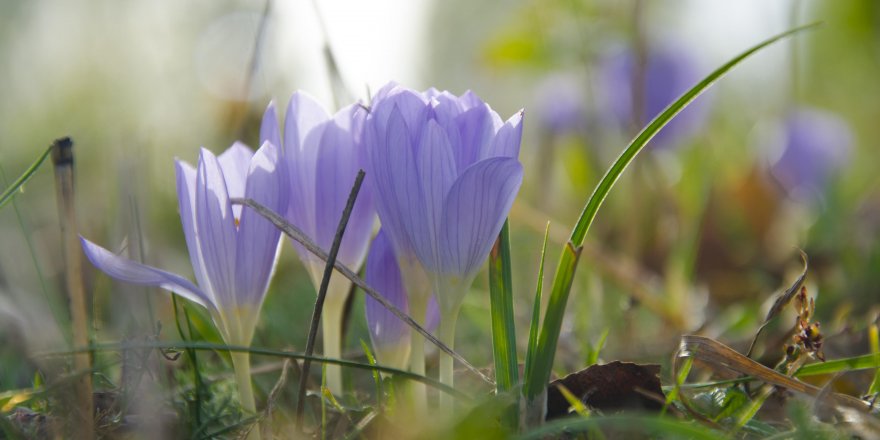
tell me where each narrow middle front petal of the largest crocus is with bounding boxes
[412,120,457,269]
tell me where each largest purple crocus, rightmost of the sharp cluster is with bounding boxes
[364,84,523,396]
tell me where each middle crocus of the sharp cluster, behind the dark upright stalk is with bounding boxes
[260,92,376,395]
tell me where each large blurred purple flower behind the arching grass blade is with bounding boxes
[597,46,708,149]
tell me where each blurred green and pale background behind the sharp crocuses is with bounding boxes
[0,0,880,398]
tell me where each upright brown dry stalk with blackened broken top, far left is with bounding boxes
[52,137,94,438]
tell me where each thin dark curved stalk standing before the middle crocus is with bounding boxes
[296,170,364,432]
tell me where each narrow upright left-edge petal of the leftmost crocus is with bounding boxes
[174,160,214,302]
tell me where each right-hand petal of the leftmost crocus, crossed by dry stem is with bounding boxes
[235,141,287,307]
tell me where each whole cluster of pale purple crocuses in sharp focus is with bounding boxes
[82,84,523,413]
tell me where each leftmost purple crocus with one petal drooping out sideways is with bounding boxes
[81,142,287,412]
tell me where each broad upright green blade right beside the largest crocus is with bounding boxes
[489,221,519,393]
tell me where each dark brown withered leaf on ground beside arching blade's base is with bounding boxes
[547,361,663,420]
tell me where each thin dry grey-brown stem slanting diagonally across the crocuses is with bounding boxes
[230,198,495,385]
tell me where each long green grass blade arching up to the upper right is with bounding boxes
[523,23,818,399]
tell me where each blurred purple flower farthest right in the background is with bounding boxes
[771,107,853,200]
